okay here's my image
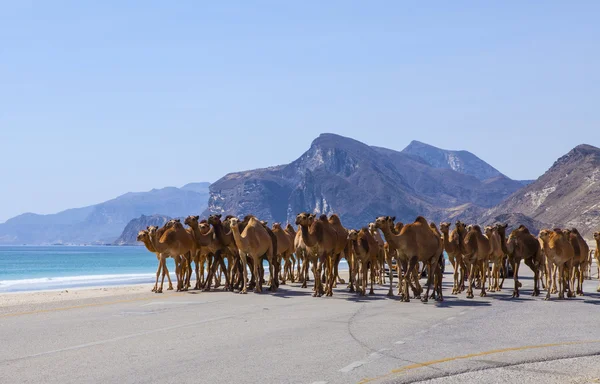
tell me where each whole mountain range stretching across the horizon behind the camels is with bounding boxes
[0,134,600,244]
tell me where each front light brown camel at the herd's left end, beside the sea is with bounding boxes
[148,220,196,292]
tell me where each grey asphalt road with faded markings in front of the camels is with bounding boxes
[0,266,600,384]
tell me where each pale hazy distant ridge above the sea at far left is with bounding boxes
[0,183,208,244]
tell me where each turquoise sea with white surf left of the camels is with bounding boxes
[0,246,347,293]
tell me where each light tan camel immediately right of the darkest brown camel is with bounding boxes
[539,228,575,300]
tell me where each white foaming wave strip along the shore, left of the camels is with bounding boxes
[0,273,175,292]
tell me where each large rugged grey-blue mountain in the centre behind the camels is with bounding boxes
[204,134,522,227]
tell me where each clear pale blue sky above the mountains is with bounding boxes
[0,0,600,222]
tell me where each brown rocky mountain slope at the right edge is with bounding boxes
[482,144,600,237]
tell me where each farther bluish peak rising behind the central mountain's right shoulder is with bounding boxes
[402,140,504,181]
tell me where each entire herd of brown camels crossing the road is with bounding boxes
[137,212,600,302]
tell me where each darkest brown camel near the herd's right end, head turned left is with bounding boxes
[506,225,545,297]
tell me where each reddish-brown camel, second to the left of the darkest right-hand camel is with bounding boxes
[463,225,490,299]
